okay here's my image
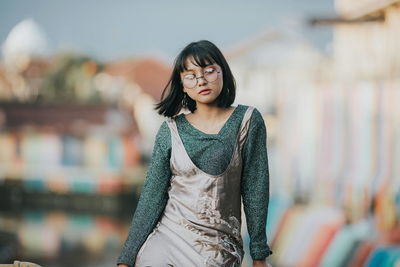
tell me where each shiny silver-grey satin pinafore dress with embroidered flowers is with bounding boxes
[135,107,254,267]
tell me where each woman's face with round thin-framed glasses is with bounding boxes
[181,57,223,105]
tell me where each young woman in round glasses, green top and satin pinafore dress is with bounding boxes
[117,40,272,267]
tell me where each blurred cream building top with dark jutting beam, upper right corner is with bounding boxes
[334,0,400,80]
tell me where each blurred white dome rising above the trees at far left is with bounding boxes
[2,19,48,70]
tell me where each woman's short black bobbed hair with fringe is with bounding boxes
[155,40,236,117]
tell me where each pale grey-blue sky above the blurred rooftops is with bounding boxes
[0,0,335,61]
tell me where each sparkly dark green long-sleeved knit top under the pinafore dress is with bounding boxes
[117,104,272,266]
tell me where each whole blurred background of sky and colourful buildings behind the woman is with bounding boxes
[0,0,400,267]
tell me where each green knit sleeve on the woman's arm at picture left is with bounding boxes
[117,121,171,266]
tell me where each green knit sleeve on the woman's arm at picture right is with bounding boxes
[241,109,272,260]
